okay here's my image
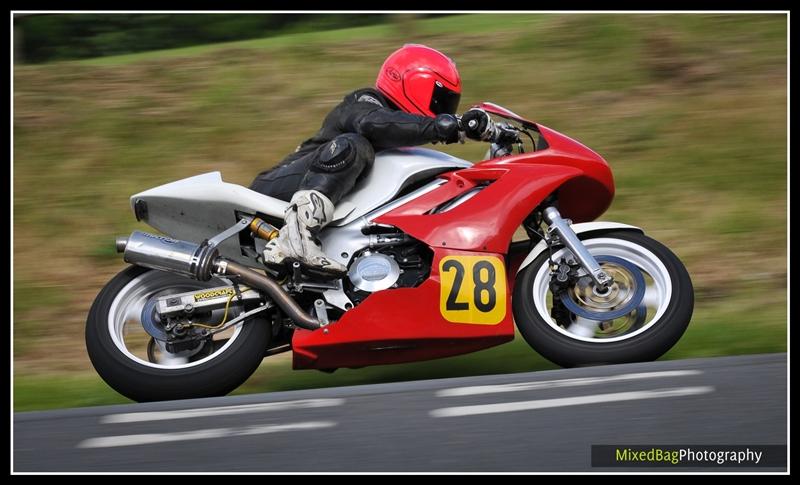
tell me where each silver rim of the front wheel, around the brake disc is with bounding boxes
[533,238,672,344]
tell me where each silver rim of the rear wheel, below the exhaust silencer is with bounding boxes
[108,271,242,369]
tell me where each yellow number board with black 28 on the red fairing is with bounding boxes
[439,256,506,325]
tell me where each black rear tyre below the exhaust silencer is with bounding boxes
[86,266,271,402]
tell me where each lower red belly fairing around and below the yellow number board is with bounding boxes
[292,248,514,369]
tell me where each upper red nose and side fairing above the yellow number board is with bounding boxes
[375,121,614,254]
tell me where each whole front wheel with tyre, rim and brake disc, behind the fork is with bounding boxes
[512,231,694,367]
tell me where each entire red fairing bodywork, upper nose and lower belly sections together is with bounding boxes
[292,114,614,369]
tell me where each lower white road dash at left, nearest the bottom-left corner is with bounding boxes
[78,421,336,448]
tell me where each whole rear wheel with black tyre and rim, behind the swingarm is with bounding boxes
[86,266,271,402]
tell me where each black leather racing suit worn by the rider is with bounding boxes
[250,88,458,204]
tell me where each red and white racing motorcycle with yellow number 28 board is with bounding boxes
[86,103,694,401]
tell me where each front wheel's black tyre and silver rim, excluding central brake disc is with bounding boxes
[512,231,694,367]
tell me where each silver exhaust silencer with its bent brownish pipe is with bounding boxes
[116,231,322,330]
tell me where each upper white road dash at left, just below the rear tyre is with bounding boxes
[100,399,344,424]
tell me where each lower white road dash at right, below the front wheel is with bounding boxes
[430,386,714,418]
